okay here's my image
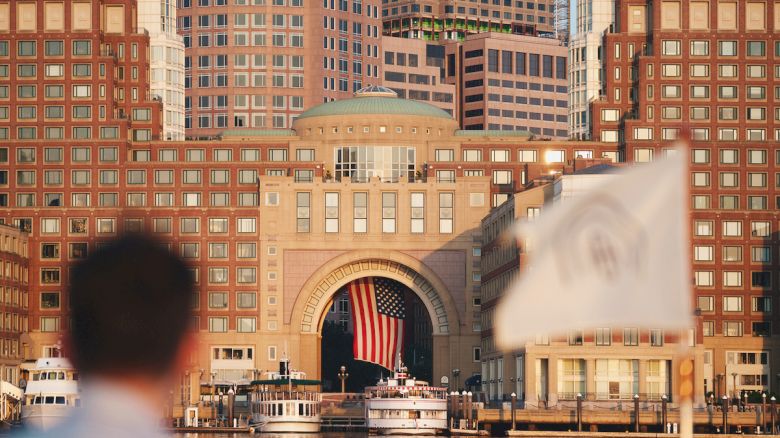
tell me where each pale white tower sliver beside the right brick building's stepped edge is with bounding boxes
[569,0,615,140]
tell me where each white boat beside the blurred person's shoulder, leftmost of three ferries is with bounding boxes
[22,357,81,430]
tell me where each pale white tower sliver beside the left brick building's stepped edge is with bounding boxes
[138,0,184,141]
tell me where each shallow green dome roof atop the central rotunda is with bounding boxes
[298,96,452,120]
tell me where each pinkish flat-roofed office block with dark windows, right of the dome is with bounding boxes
[446,33,568,139]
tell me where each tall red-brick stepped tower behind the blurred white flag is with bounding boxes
[592,0,780,398]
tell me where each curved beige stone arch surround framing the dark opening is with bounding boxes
[289,251,460,384]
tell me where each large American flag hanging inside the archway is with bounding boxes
[348,277,406,370]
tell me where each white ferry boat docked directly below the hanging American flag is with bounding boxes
[365,358,447,435]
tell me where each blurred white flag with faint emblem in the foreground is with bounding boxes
[495,153,693,349]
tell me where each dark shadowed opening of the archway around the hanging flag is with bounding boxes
[320,279,433,392]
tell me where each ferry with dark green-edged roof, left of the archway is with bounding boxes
[249,358,322,433]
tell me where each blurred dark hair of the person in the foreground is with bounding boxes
[70,234,193,375]
